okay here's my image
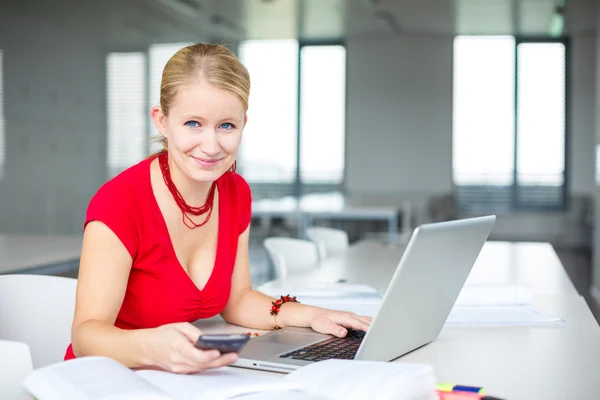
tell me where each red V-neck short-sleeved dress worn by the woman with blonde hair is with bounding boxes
[65,159,252,360]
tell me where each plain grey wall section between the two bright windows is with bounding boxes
[346,36,452,197]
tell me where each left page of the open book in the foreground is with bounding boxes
[23,357,173,400]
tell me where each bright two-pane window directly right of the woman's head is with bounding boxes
[238,40,346,196]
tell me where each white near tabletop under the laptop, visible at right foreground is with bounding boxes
[196,290,600,400]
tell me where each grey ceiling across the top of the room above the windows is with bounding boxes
[0,0,600,47]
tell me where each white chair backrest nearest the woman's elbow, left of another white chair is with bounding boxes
[263,237,319,278]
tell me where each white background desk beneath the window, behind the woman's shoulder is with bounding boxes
[252,193,423,242]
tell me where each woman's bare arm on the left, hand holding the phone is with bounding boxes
[71,221,235,373]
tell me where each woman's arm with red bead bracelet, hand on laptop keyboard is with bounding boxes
[221,228,371,336]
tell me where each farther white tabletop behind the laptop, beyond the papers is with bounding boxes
[260,240,578,295]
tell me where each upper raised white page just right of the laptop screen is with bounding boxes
[454,284,533,306]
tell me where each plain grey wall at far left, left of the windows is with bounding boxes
[0,7,106,233]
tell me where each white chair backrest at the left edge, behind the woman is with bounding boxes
[0,275,77,368]
